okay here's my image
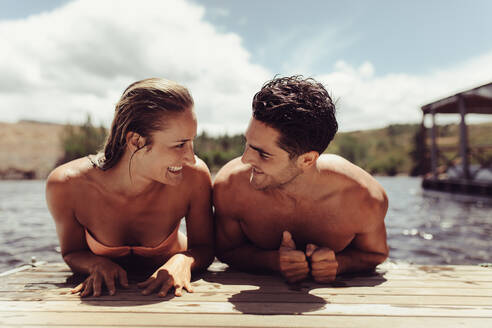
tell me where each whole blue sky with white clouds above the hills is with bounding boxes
[0,0,492,134]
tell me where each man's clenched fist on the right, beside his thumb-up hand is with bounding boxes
[306,244,338,283]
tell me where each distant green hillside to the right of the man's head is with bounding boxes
[327,123,492,175]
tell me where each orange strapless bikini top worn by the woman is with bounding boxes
[85,224,179,257]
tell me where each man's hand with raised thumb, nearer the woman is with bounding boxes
[278,231,309,282]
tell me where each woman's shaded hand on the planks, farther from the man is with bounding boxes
[71,258,128,297]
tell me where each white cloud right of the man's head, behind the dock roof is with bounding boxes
[317,53,492,131]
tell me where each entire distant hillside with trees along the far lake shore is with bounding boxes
[0,121,492,179]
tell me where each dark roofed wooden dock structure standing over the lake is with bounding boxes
[421,83,492,197]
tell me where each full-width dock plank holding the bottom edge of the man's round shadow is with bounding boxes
[0,300,492,318]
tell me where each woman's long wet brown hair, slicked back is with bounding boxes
[91,78,193,170]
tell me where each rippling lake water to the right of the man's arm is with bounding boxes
[377,177,492,264]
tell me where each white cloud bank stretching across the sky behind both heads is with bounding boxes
[0,0,492,136]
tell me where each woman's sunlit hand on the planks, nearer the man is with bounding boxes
[137,254,193,297]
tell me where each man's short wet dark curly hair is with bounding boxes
[253,75,338,159]
